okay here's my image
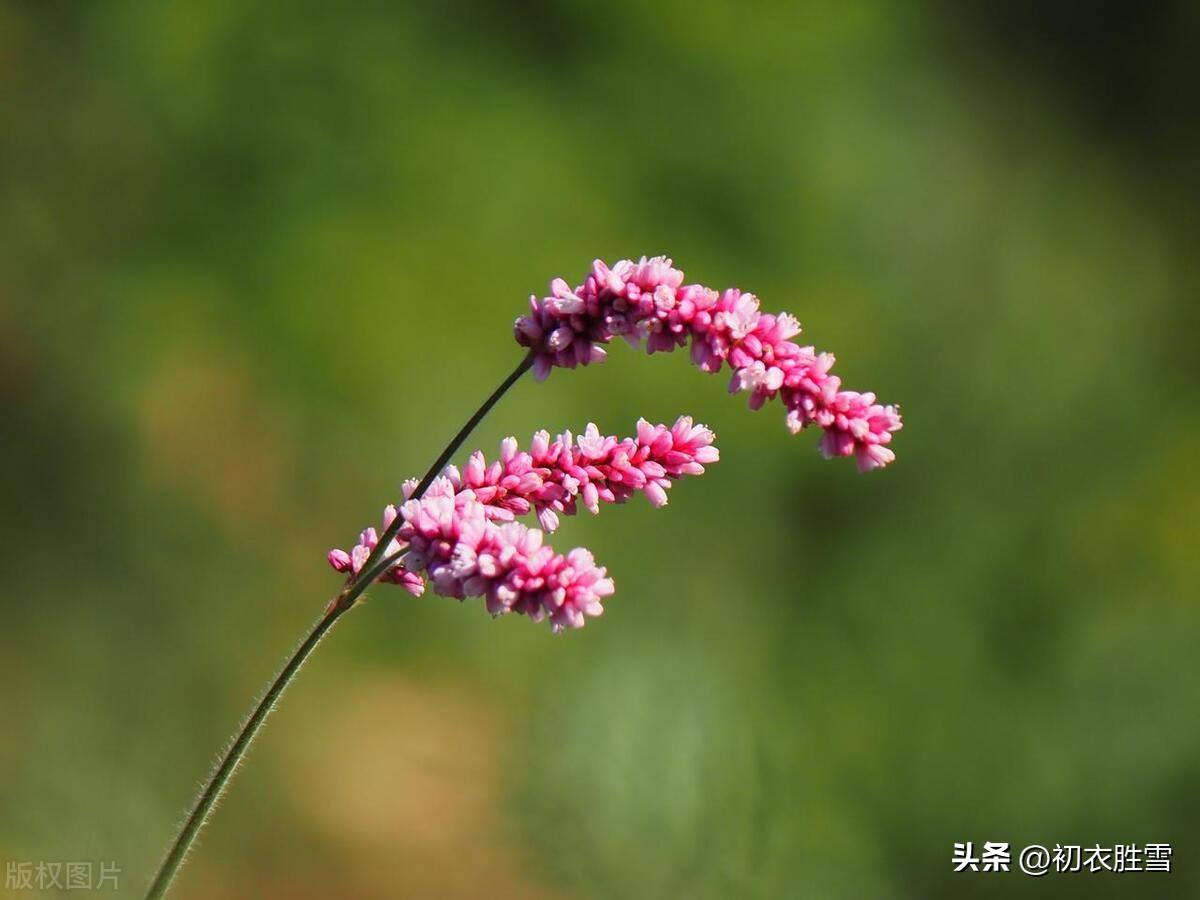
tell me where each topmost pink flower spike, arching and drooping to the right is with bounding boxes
[515,257,901,472]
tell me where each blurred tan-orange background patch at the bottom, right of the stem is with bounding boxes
[284,677,563,900]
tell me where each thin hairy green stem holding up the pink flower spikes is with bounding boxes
[146,354,533,900]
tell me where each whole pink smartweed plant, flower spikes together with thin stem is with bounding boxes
[146,257,900,898]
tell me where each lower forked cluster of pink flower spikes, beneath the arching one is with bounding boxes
[329,416,719,630]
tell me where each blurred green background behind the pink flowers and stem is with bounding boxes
[0,0,1200,899]
